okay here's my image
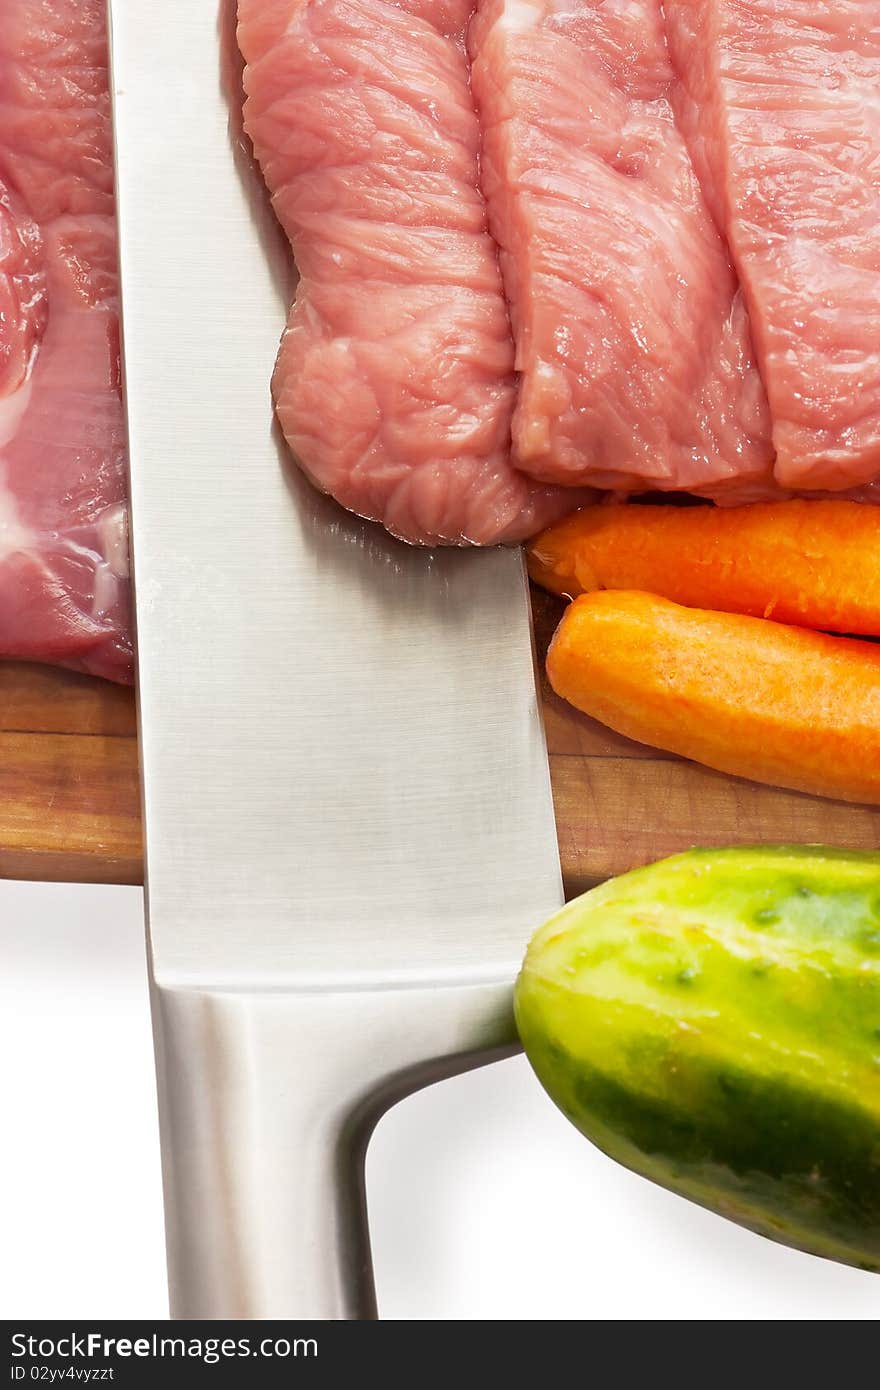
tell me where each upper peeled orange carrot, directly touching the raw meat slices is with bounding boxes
[528,500,880,637]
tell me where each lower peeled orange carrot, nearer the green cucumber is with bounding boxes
[546,592,880,803]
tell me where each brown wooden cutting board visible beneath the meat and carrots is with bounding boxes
[0,591,880,895]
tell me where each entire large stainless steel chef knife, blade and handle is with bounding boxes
[110,0,562,1318]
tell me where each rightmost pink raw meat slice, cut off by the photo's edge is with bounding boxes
[666,0,880,488]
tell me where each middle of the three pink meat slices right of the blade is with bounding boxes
[468,0,772,496]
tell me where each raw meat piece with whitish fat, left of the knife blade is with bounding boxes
[0,0,132,680]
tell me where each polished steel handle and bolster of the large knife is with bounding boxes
[153,980,517,1321]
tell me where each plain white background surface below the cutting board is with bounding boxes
[0,883,880,1321]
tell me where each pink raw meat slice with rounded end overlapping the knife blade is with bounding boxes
[239,0,578,543]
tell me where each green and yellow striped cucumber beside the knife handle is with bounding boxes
[516,847,880,1270]
